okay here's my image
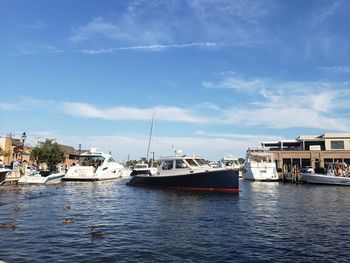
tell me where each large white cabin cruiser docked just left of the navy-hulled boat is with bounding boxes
[63,148,131,181]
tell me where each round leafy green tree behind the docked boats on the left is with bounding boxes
[30,139,65,170]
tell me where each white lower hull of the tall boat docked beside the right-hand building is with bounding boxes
[243,163,279,181]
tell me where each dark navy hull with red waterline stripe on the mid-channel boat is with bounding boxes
[128,169,239,192]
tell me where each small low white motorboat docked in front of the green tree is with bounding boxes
[18,171,66,184]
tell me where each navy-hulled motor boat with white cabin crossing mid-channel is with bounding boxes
[127,152,239,192]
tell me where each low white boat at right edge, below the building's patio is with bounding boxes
[301,163,350,186]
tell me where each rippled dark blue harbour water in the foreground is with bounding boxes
[0,180,350,262]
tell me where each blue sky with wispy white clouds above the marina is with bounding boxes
[0,0,350,161]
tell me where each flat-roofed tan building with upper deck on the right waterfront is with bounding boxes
[261,133,350,172]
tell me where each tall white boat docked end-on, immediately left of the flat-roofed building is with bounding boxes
[243,149,279,181]
